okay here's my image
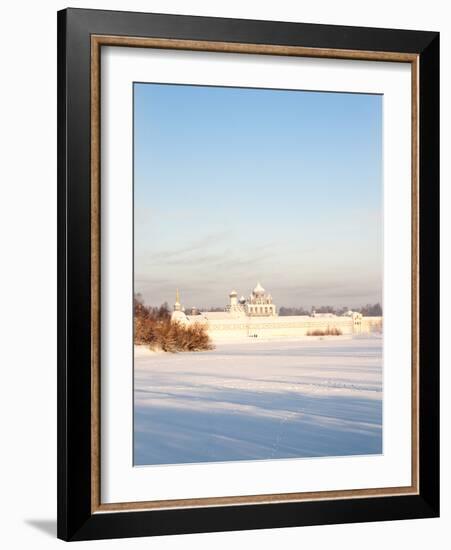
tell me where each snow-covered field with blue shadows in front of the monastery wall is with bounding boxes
[134,336,382,465]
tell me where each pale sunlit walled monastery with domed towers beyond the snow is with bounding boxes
[172,282,382,341]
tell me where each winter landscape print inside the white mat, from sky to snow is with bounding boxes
[133,83,383,465]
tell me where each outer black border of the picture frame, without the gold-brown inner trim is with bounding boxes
[58,9,439,540]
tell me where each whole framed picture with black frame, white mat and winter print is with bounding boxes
[58,9,439,540]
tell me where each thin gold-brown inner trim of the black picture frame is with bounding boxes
[91,35,419,513]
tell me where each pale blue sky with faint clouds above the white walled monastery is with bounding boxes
[134,83,383,308]
